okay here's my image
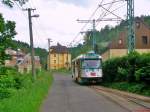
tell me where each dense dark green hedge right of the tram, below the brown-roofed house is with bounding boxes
[103,52,150,83]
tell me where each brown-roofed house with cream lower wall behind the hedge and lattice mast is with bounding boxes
[102,18,150,61]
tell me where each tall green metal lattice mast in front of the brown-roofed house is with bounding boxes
[126,0,135,53]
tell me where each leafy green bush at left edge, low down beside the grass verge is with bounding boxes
[0,67,22,99]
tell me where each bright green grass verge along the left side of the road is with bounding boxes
[0,71,53,112]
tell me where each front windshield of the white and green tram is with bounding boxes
[82,60,101,69]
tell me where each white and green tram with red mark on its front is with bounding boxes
[72,51,102,84]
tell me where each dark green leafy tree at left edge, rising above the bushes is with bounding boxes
[0,14,16,65]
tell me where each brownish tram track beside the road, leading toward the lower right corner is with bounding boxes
[89,86,150,112]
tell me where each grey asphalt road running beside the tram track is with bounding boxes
[40,73,128,112]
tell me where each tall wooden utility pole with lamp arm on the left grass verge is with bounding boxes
[25,8,39,81]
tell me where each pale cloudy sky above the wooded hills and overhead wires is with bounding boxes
[0,0,150,49]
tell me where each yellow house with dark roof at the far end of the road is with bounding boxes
[47,43,71,70]
